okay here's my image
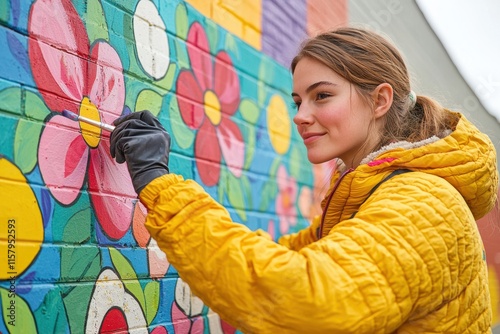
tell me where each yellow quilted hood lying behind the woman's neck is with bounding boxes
[358,111,498,219]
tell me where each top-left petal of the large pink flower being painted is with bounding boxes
[28,1,89,111]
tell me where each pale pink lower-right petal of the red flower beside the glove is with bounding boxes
[217,114,245,177]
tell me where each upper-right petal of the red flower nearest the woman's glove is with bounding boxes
[214,51,240,115]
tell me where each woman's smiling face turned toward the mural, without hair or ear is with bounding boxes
[292,57,377,168]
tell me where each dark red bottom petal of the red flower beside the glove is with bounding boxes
[194,121,221,187]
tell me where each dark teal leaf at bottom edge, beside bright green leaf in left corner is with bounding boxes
[34,289,69,333]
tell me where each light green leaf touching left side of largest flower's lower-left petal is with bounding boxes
[14,118,43,174]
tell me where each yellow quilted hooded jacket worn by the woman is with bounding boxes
[140,112,498,334]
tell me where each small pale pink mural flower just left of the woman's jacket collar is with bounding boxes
[276,165,297,234]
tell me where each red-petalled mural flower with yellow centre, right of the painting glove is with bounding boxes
[177,22,245,186]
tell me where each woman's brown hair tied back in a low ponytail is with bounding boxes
[291,28,445,150]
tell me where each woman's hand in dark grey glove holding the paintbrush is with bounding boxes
[110,110,170,194]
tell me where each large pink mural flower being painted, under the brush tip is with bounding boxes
[28,0,134,239]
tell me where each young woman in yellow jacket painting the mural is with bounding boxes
[111,28,498,333]
